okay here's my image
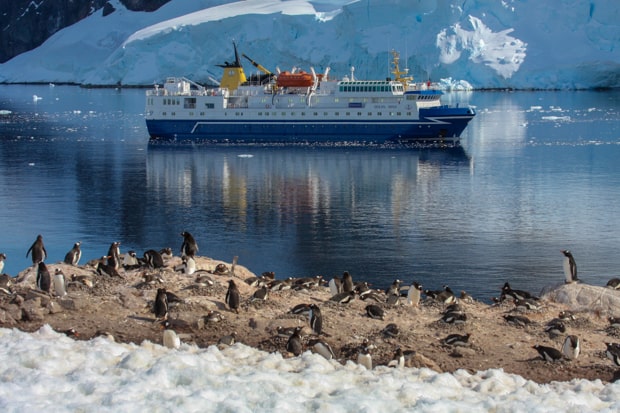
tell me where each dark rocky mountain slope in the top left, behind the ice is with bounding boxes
[0,0,170,63]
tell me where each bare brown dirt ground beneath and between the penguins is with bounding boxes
[0,257,620,383]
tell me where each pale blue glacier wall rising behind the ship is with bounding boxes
[0,0,620,89]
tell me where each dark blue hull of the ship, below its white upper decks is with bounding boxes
[146,106,475,143]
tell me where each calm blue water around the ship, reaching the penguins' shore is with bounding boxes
[0,85,620,300]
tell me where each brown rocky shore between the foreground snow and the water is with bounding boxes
[0,257,620,383]
